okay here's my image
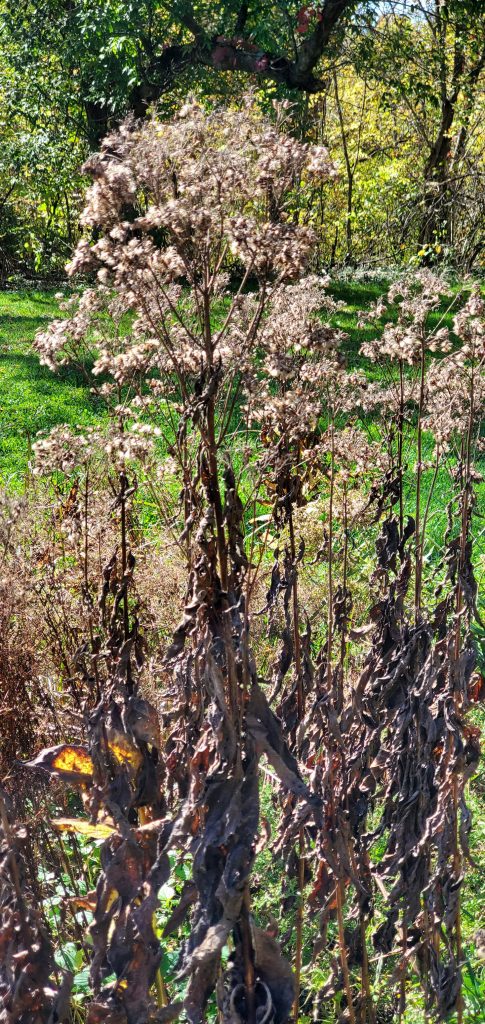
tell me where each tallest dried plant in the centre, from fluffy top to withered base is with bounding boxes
[32,97,339,1024]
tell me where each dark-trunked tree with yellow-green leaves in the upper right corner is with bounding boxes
[356,0,485,258]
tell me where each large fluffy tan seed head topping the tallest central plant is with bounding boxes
[36,97,343,469]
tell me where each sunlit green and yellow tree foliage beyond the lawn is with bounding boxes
[0,0,485,284]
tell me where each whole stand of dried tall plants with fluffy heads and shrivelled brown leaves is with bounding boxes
[0,103,484,1024]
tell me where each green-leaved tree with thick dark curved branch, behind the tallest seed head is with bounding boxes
[3,0,361,142]
